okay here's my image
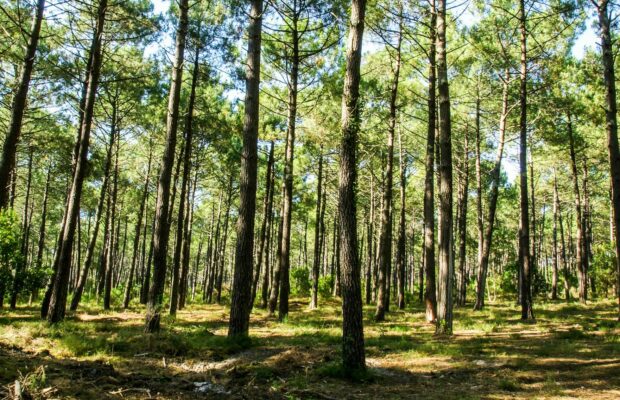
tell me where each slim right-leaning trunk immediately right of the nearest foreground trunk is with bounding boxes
[375,10,403,321]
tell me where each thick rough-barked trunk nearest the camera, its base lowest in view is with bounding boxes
[338,0,366,373]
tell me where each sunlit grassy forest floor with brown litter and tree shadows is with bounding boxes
[0,299,620,400]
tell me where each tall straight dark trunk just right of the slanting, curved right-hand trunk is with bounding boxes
[519,0,534,320]
